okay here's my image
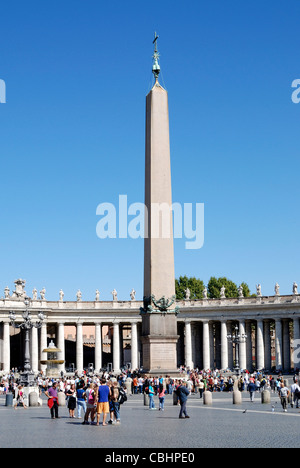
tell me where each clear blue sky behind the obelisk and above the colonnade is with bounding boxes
[0,0,300,300]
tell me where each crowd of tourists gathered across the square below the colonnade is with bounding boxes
[0,368,300,416]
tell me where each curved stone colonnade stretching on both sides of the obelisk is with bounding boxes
[0,296,300,372]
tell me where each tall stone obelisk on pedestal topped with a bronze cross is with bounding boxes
[141,34,178,375]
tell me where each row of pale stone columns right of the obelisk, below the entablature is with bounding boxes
[184,317,300,370]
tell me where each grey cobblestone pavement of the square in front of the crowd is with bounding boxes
[0,392,300,449]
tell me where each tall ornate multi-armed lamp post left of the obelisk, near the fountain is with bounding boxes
[9,297,45,387]
